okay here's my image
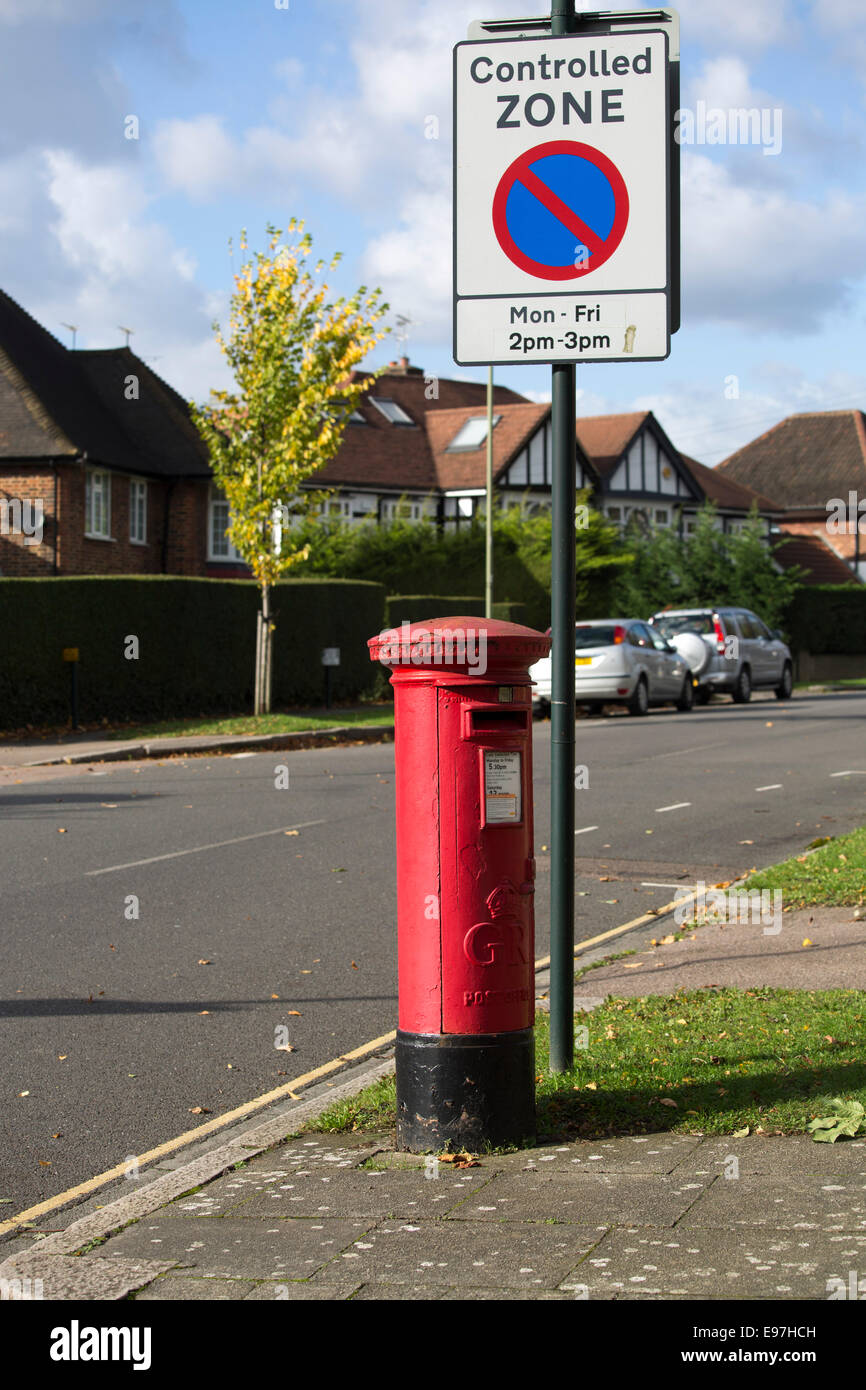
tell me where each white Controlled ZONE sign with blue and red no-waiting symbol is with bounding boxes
[455,29,671,366]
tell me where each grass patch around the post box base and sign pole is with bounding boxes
[314,990,866,1141]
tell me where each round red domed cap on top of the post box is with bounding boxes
[367,614,550,670]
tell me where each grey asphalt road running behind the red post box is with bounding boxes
[0,694,866,1219]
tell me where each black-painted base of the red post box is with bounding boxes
[396,1029,535,1154]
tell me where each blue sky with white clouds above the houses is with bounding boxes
[0,0,866,463]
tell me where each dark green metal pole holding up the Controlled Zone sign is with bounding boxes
[550,0,577,1072]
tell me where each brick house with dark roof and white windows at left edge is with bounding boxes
[0,291,210,575]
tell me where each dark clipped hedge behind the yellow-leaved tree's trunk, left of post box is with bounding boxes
[0,575,385,728]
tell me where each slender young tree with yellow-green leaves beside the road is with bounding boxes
[190,218,388,714]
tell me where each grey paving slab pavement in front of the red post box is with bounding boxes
[6,1134,866,1302]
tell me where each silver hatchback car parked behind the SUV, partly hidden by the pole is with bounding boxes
[530,619,695,714]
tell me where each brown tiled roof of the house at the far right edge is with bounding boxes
[719,410,866,507]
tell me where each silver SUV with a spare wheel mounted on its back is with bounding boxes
[649,607,794,705]
